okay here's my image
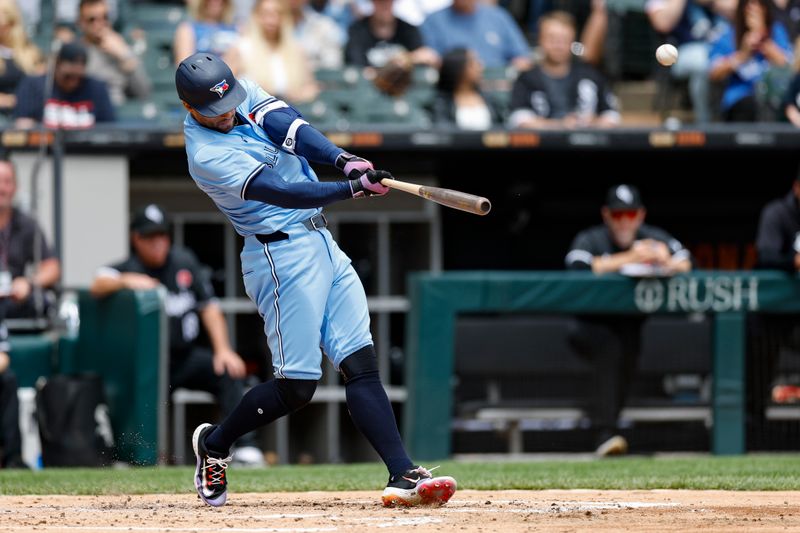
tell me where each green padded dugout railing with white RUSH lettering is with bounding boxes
[403,271,800,460]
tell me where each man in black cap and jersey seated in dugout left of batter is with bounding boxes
[90,204,264,465]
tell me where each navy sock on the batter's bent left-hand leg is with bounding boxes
[206,379,290,456]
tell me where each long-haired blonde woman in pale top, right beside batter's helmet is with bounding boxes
[225,0,319,103]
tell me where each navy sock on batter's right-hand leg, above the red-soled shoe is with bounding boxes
[345,371,414,476]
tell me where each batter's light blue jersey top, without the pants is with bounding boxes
[183,79,320,237]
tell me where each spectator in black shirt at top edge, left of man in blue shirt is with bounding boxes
[345,0,439,68]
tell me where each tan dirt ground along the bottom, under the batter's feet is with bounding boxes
[0,487,800,533]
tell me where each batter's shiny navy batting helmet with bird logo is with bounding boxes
[175,52,247,117]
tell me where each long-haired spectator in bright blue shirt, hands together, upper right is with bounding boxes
[709,0,793,122]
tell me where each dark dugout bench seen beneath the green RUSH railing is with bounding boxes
[452,314,711,454]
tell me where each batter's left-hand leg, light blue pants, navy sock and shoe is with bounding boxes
[193,231,333,505]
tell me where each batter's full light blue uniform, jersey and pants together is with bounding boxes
[184,79,372,379]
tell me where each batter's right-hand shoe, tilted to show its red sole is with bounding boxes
[382,466,456,507]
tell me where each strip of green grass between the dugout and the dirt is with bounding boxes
[0,455,800,495]
